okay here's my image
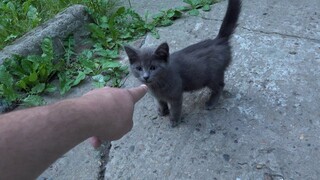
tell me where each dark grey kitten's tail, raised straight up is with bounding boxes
[218,0,241,40]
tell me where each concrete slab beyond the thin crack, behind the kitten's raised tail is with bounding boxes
[204,0,320,42]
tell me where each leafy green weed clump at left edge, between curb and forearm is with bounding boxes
[0,39,60,106]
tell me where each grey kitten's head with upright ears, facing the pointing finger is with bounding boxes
[124,43,169,85]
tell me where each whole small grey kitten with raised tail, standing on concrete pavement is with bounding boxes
[125,0,241,127]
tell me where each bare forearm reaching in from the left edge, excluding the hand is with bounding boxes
[0,99,92,179]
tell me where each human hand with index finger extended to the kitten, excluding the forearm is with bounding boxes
[81,85,147,148]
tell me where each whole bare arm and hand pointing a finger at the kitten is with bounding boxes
[0,85,147,179]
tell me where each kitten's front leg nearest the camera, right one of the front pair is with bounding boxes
[169,97,182,127]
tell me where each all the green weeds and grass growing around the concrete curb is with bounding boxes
[0,0,215,106]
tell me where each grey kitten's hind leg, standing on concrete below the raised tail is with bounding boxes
[205,81,224,110]
